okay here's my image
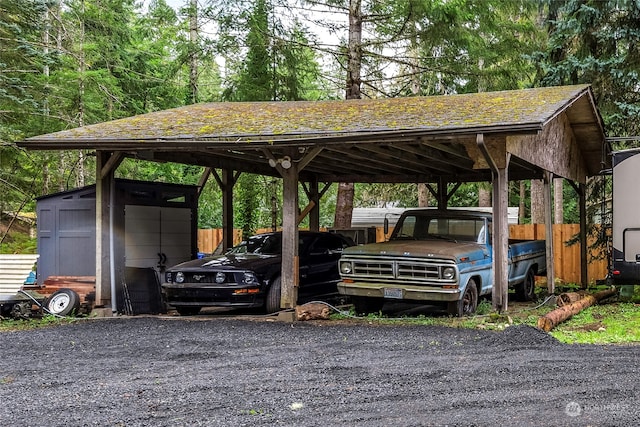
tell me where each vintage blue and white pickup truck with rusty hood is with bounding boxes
[338,209,546,316]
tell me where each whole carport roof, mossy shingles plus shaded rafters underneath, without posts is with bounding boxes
[19,85,604,182]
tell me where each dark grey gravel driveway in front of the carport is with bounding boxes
[0,316,640,427]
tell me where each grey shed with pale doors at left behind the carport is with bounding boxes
[36,179,198,312]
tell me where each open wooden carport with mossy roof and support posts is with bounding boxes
[18,85,607,311]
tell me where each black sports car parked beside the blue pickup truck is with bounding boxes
[162,231,355,315]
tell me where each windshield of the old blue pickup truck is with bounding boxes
[391,215,485,243]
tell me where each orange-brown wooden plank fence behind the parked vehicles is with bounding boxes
[198,224,607,284]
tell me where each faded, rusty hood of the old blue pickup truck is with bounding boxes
[342,240,489,261]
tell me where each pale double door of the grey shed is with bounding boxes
[124,205,191,271]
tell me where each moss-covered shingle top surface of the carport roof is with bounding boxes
[26,85,589,146]
